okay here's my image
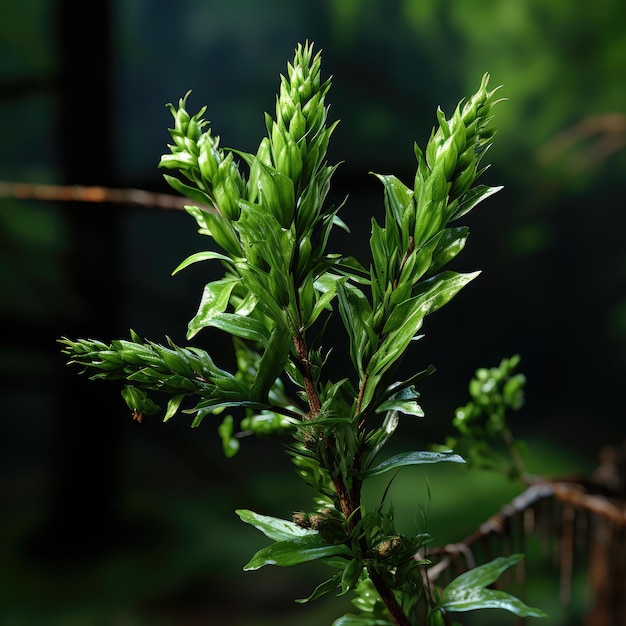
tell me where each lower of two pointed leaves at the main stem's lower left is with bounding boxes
[243,531,350,571]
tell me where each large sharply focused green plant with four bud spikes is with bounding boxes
[62,44,542,626]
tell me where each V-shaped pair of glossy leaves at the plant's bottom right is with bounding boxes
[435,554,547,617]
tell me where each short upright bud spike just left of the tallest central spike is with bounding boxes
[159,92,246,220]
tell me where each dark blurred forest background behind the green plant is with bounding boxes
[0,0,626,625]
